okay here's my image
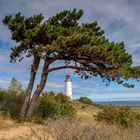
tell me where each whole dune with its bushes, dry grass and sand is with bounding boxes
[0,79,140,140]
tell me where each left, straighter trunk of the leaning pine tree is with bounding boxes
[20,56,40,118]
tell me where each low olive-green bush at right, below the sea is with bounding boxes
[97,106,139,127]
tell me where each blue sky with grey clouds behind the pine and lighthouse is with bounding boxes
[0,0,140,101]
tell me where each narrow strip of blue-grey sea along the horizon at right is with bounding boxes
[95,101,140,107]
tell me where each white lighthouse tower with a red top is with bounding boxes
[65,73,72,99]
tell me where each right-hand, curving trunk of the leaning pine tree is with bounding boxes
[26,61,48,117]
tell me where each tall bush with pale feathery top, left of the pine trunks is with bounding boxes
[0,78,25,118]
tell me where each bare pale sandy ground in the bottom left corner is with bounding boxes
[0,123,53,140]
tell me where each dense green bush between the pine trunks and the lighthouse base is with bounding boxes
[39,93,76,117]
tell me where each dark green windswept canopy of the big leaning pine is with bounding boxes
[3,9,140,85]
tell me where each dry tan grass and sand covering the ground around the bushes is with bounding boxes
[0,101,140,140]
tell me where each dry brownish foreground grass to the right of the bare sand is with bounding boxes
[46,118,140,140]
